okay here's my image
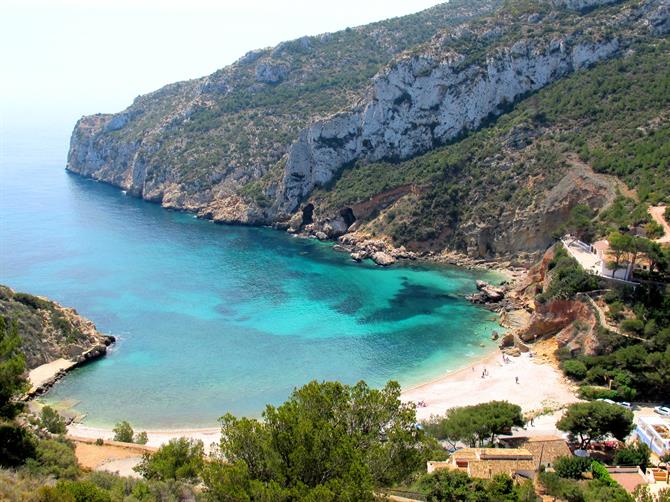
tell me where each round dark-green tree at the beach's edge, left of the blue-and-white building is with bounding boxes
[556,401,633,449]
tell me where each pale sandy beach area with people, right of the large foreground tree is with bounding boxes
[402,344,578,420]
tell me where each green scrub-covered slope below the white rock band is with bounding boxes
[313,41,670,249]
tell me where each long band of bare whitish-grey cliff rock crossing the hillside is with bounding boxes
[278,35,619,213]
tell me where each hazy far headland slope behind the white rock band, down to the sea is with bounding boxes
[67,0,502,223]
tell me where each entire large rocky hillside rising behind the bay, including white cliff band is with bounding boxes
[68,0,670,261]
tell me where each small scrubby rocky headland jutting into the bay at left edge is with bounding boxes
[0,286,114,370]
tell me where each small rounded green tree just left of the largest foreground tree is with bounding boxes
[134,438,205,481]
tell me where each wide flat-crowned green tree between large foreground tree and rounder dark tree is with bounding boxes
[426,401,525,447]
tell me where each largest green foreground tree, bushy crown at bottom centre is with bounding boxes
[203,382,432,500]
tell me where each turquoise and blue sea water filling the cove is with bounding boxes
[0,133,504,427]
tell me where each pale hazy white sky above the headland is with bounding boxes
[0,0,440,144]
